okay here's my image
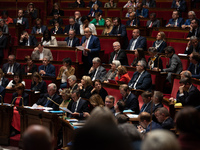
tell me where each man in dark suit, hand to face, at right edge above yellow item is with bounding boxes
[176,78,200,107]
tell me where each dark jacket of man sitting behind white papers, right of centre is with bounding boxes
[123,93,139,114]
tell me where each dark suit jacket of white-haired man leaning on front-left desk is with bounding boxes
[36,93,62,110]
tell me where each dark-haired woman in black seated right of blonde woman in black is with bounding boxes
[91,79,108,102]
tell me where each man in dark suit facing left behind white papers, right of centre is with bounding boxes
[119,84,139,114]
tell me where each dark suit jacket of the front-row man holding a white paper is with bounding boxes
[70,99,89,118]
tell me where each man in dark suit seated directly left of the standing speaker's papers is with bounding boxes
[65,29,80,47]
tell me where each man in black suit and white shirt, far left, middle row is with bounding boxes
[2,55,21,75]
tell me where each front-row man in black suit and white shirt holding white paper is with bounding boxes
[70,90,89,119]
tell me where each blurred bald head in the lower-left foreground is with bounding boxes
[23,125,53,150]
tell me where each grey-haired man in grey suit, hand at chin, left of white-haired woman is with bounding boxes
[89,57,106,81]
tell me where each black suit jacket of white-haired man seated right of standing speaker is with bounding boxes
[109,49,128,66]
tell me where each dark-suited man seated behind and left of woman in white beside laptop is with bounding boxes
[31,18,47,34]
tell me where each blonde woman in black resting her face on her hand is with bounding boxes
[78,76,93,99]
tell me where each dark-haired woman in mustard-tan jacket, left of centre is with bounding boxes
[57,57,75,88]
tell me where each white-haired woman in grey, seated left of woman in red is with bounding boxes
[103,60,121,83]
